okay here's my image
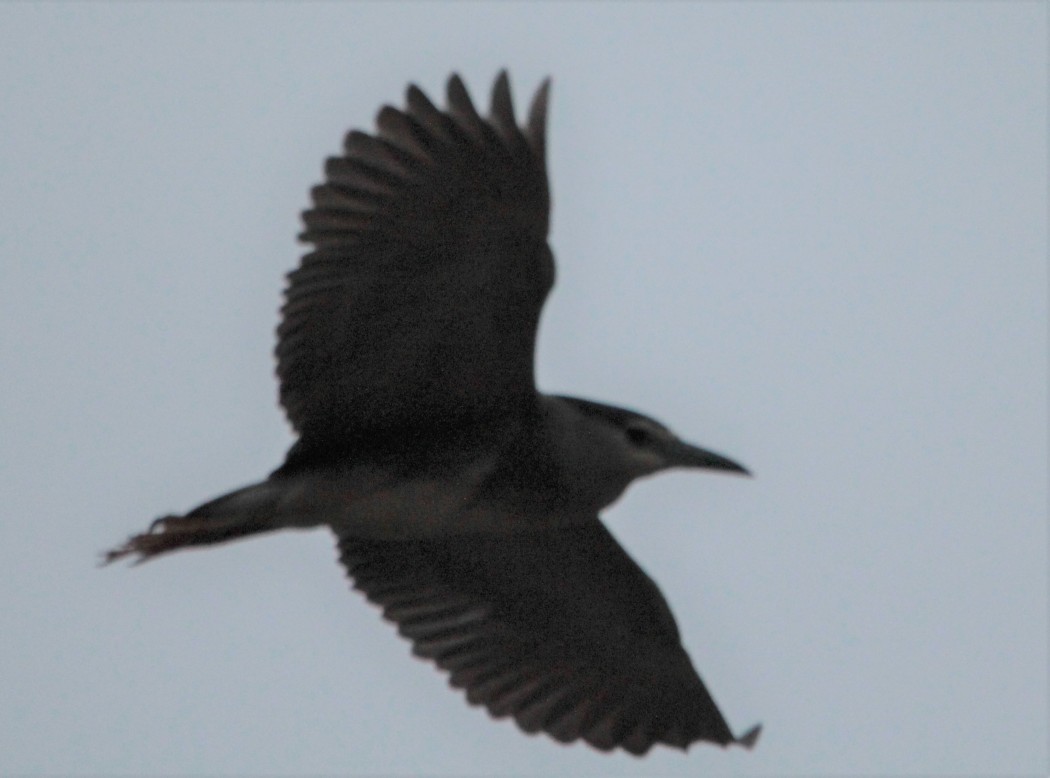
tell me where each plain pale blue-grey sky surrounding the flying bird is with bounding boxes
[0,2,1048,775]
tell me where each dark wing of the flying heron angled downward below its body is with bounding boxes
[339,519,758,754]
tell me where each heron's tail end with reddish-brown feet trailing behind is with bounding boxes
[102,481,282,565]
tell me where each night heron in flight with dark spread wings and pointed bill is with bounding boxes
[105,72,759,754]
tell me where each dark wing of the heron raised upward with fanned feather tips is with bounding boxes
[276,72,554,449]
